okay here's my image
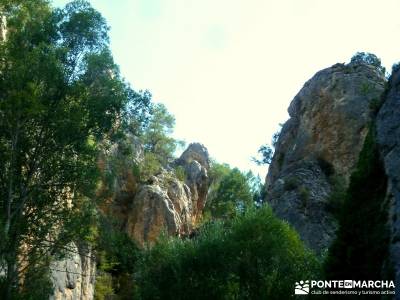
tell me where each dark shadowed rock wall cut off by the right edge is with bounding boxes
[376,70,400,299]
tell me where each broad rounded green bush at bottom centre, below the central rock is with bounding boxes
[136,206,318,300]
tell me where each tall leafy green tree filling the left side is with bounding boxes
[0,0,146,299]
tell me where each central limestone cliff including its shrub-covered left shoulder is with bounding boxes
[100,136,210,245]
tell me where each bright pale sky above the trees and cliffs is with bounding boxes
[53,0,400,177]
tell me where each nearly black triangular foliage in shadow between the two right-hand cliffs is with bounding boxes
[325,126,389,280]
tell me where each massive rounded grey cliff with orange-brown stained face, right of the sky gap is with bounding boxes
[266,63,385,252]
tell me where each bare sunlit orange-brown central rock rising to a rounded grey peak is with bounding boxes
[119,143,210,245]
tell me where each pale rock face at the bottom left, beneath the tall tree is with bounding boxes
[50,243,96,300]
